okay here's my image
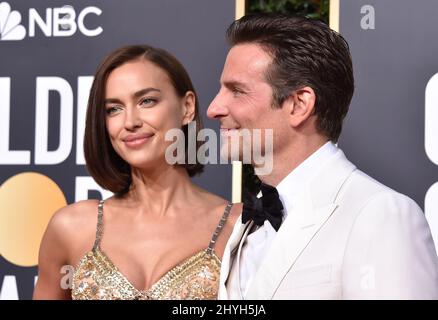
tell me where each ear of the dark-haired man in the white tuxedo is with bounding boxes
[283,87,316,127]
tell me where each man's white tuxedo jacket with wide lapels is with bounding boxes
[219,150,438,300]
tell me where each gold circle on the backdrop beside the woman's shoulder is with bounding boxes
[0,172,67,267]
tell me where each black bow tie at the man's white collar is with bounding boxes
[242,183,283,231]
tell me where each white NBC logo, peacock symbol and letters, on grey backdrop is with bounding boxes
[0,2,103,40]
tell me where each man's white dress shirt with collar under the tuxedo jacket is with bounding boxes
[239,141,337,298]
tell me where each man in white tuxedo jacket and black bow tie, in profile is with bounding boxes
[207,14,438,299]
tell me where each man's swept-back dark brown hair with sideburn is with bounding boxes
[227,14,354,142]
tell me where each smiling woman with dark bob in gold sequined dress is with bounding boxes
[34,45,241,299]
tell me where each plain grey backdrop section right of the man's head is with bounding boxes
[339,0,438,250]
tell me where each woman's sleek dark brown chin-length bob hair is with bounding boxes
[84,45,203,195]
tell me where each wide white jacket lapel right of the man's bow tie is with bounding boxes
[246,150,355,300]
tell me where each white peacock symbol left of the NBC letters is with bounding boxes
[0,2,26,40]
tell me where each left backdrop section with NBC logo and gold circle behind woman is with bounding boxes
[0,0,235,299]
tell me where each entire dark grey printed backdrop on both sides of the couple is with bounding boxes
[0,0,438,299]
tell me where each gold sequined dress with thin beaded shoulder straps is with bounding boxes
[72,201,232,300]
